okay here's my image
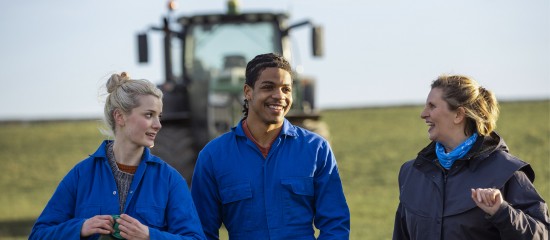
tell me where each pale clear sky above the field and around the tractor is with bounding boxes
[0,0,550,120]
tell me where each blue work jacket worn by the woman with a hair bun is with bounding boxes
[29,141,204,239]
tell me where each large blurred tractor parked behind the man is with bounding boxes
[138,1,329,183]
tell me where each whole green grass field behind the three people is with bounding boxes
[0,100,550,239]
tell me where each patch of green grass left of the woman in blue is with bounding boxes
[0,121,103,220]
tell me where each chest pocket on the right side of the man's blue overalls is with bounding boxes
[281,177,315,225]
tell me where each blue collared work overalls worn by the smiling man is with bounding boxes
[191,119,350,239]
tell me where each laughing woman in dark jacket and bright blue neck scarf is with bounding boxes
[393,75,550,240]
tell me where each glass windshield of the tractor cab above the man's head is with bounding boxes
[185,22,281,81]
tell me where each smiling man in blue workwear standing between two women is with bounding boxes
[191,53,350,239]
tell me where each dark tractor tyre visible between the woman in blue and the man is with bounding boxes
[151,125,197,186]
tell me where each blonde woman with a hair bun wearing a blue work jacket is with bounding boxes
[29,73,204,239]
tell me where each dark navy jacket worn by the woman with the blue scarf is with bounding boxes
[393,132,550,240]
